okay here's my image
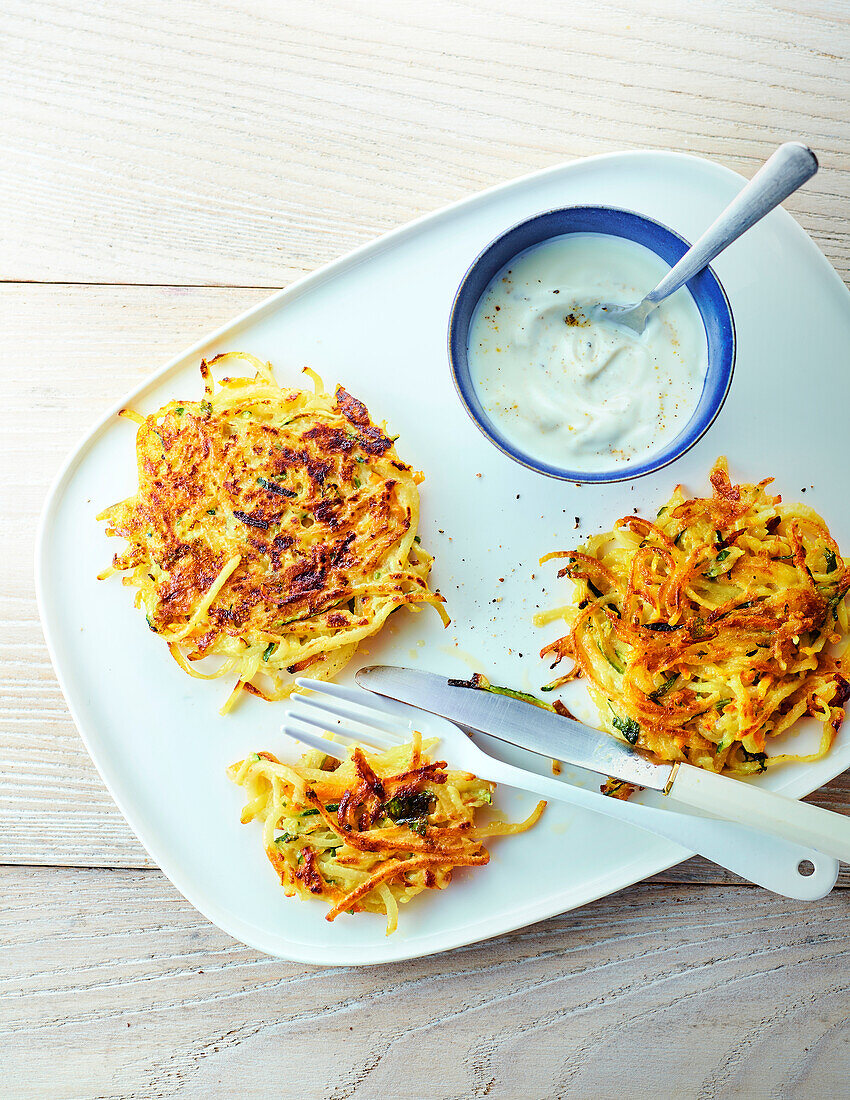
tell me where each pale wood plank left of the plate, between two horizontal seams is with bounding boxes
[0,284,265,867]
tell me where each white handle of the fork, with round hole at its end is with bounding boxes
[481,757,838,901]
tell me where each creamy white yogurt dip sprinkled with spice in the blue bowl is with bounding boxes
[468,233,708,473]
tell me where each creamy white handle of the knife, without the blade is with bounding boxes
[667,763,850,862]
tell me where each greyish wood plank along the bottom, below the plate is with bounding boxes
[0,868,850,1100]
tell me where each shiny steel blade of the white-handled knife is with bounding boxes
[354,664,673,791]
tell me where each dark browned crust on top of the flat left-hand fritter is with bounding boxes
[102,363,435,660]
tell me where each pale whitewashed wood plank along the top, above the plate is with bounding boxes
[0,0,850,286]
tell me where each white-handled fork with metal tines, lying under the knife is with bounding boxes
[282,677,838,901]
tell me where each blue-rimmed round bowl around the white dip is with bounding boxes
[449,206,736,482]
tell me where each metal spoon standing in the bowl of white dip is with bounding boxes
[585,141,818,334]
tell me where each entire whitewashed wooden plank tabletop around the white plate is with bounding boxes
[0,0,850,1100]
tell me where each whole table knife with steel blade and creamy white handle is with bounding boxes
[354,664,850,861]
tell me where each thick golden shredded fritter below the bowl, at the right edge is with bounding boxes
[538,459,850,778]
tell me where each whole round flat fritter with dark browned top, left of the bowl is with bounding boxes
[98,353,449,711]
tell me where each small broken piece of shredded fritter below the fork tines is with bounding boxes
[228,733,545,935]
